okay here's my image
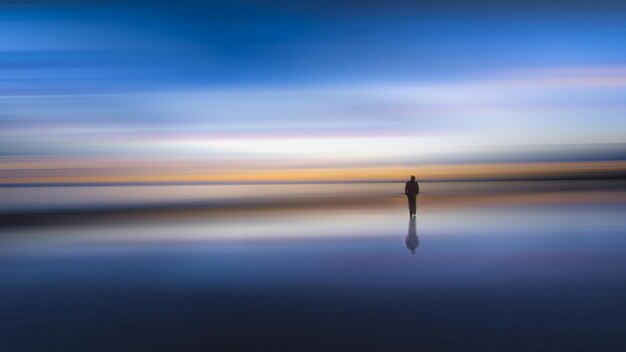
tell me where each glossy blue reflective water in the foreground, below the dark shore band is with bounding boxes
[0,202,626,352]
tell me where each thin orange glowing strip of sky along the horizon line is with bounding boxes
[0,161,626,185]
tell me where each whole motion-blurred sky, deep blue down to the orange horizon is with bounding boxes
[0,0,626,183]
